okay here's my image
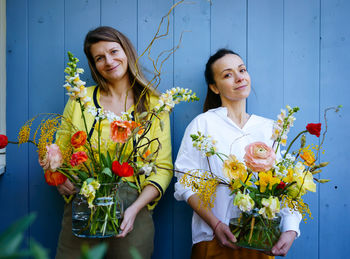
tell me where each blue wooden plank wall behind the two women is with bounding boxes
[0,0,350,259]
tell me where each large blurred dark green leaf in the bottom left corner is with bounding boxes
[0,213,36,257]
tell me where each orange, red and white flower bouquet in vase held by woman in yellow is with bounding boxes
[0,52,198,240]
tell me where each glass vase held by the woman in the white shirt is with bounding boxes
[229,212,281,251]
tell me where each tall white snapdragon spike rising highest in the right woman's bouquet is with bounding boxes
[271,105,296,146]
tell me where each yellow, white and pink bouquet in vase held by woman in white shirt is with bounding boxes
[180,106,341,251]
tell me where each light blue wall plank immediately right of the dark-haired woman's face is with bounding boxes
[247,0,283,118]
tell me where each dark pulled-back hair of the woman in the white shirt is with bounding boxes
[203,49,240,112]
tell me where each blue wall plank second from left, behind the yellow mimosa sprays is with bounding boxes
[28,0,64,257]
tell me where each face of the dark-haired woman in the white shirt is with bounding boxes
[209,54,250,106]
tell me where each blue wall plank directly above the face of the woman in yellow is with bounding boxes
[101,0,137,46]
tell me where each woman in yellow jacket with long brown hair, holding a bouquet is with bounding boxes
[56,26,172,259]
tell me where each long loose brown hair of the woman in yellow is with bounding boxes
[84,26,155,113]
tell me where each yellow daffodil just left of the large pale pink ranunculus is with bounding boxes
[223,155,252,190]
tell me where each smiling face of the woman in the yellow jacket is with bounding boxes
[90,41,128,83]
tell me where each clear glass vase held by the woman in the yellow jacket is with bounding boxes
[72,183,124,238]
